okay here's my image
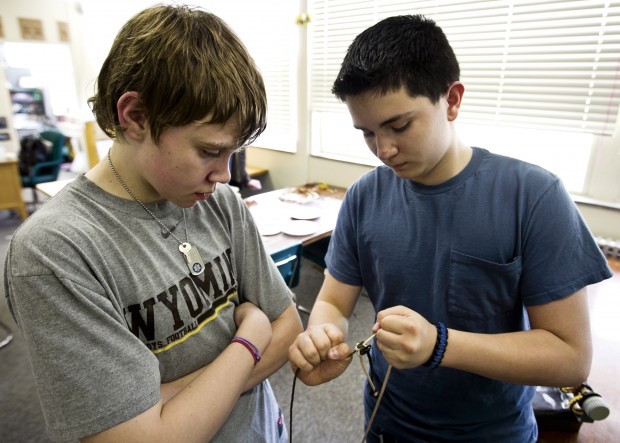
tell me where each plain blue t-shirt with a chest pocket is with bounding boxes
[326,148,612,443]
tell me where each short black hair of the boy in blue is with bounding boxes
[332,15,460,103]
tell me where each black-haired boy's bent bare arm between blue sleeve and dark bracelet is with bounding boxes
[442,289,592,386]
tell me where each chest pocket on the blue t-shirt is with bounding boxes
[448,249,523,326]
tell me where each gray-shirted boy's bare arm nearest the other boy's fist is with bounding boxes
[244,304,303,391]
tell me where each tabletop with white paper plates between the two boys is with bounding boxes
[245,183,345,255]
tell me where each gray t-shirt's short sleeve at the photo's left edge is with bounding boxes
[7,258,160,441]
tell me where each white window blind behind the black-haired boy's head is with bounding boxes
[309,0,620,135]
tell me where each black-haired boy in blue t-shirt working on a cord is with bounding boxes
[289,16,612,443]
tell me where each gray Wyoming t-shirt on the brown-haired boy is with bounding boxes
[5,176,292,442]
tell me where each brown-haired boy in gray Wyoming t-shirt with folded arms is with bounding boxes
[5,6,301,442]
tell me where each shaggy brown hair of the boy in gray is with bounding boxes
[88,5,267,145]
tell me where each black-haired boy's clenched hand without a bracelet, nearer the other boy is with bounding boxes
[288,323,352,386]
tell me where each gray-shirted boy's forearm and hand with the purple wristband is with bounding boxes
[84,303,272,443]
